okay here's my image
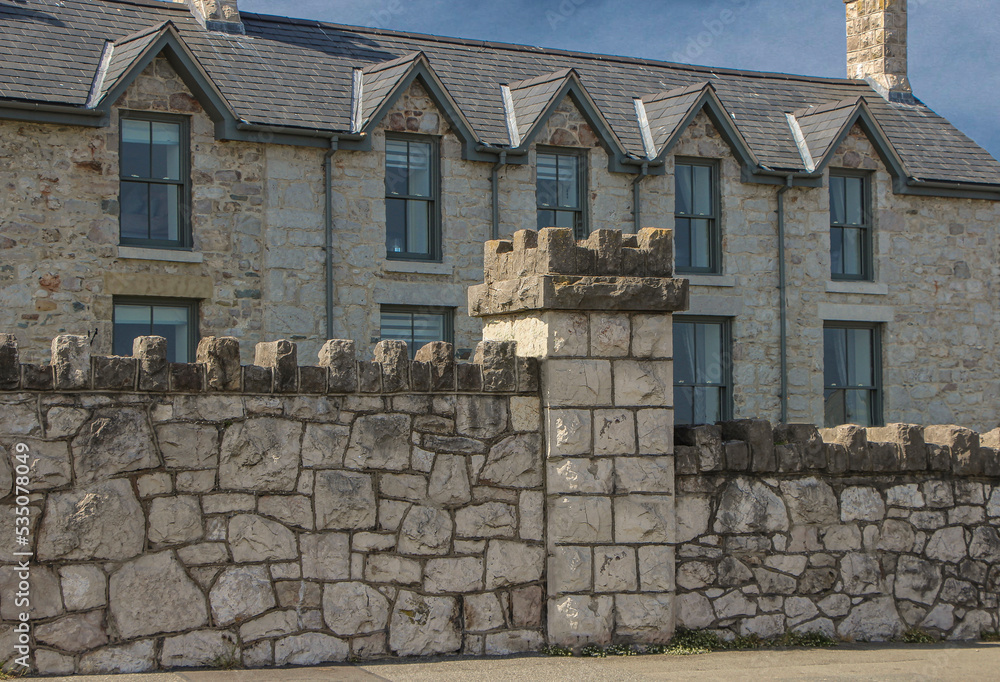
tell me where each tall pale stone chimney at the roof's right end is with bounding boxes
[844,0,912,100]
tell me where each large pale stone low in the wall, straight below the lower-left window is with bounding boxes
[108,552,208,639]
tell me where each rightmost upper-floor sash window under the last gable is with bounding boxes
[830,172,872,280]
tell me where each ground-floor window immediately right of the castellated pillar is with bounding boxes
[673,317,733,424]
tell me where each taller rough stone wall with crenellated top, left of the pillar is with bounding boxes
[0,335,545,673]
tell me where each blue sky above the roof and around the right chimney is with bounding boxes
[240,0,1000,158]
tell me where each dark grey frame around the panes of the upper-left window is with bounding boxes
[118,110,194,251]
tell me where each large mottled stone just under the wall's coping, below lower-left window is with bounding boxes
[72,407,160,483]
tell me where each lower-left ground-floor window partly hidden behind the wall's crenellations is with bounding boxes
[113,296,198,362]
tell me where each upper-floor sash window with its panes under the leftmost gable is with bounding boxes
[118,113,191,248]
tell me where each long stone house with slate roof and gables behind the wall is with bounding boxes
[0,0,1000,430]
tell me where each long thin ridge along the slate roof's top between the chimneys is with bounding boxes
[234,9,871,90]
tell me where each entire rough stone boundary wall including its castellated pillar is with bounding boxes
[0,228,1000,674]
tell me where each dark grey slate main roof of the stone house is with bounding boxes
[0,0,1000,185]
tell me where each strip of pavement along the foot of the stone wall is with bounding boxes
[35,643,1000,682]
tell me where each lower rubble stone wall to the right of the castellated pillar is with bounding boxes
[676,420,1000,641]
